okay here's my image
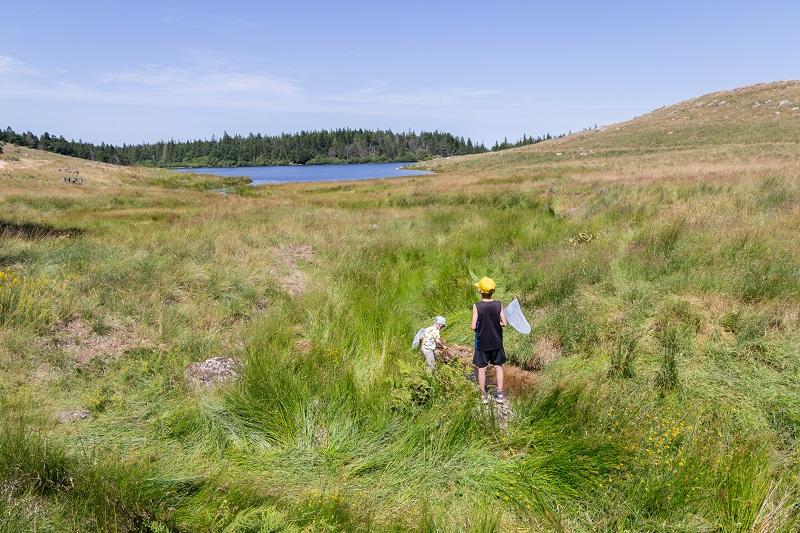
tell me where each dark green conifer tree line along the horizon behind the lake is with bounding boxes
[0,127,552,167]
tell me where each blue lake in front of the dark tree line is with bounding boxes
[176,163,433,185]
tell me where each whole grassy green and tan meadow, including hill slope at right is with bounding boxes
[0,82,800,532]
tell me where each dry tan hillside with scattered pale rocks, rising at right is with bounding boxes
[421,81,800,181]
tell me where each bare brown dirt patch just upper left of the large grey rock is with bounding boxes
[54,318,146,365]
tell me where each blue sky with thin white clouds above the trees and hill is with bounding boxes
[0,0,800,143]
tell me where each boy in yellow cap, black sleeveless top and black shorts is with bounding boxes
[471,277,507,403]
